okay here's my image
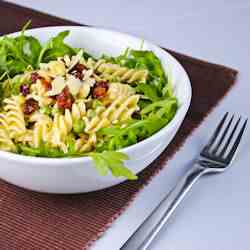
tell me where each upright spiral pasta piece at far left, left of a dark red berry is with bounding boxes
[4,96,26,140]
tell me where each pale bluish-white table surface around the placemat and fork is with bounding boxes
[7,0,250,250]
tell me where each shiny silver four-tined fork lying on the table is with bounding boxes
[120,113,247,250]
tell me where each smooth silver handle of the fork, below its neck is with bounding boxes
[120,163,206,250]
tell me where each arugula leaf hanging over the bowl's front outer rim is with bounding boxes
[88,151,137,180]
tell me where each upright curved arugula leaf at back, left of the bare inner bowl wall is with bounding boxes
[37,30,77,65]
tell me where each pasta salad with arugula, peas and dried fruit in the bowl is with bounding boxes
[0,23,178,179]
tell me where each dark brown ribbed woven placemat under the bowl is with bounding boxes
[0,1,237,250]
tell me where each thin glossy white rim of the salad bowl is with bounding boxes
[0,25,192,165]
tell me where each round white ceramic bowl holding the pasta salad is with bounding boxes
[0,26,191,193]
